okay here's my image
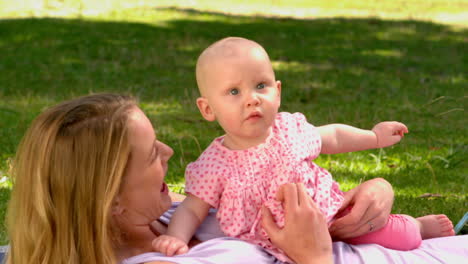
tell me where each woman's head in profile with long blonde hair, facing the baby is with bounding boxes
[7,94,331,264]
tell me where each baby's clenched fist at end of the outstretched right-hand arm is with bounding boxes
[372,121,408,148]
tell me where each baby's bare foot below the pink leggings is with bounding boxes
[416,215,455,239]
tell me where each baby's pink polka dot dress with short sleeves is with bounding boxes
[185,112,343,261]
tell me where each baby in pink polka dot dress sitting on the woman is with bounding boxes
[153,37,453,262]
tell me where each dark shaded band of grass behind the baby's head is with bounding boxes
[0,8,468,165]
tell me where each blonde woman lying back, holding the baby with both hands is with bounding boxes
[7,94,468,264]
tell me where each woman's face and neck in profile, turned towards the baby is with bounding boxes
[113,107,173,236]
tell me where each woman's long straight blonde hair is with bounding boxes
[7,94,136,264]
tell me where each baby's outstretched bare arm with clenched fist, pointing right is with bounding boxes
[317,121,408,154]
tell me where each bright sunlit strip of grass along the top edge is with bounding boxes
[0,0,468,27]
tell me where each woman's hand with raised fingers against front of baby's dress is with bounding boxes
[262,183,333,264]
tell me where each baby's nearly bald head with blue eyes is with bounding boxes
[196,37,281,148]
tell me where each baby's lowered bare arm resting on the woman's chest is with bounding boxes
[152,194,210,256]
